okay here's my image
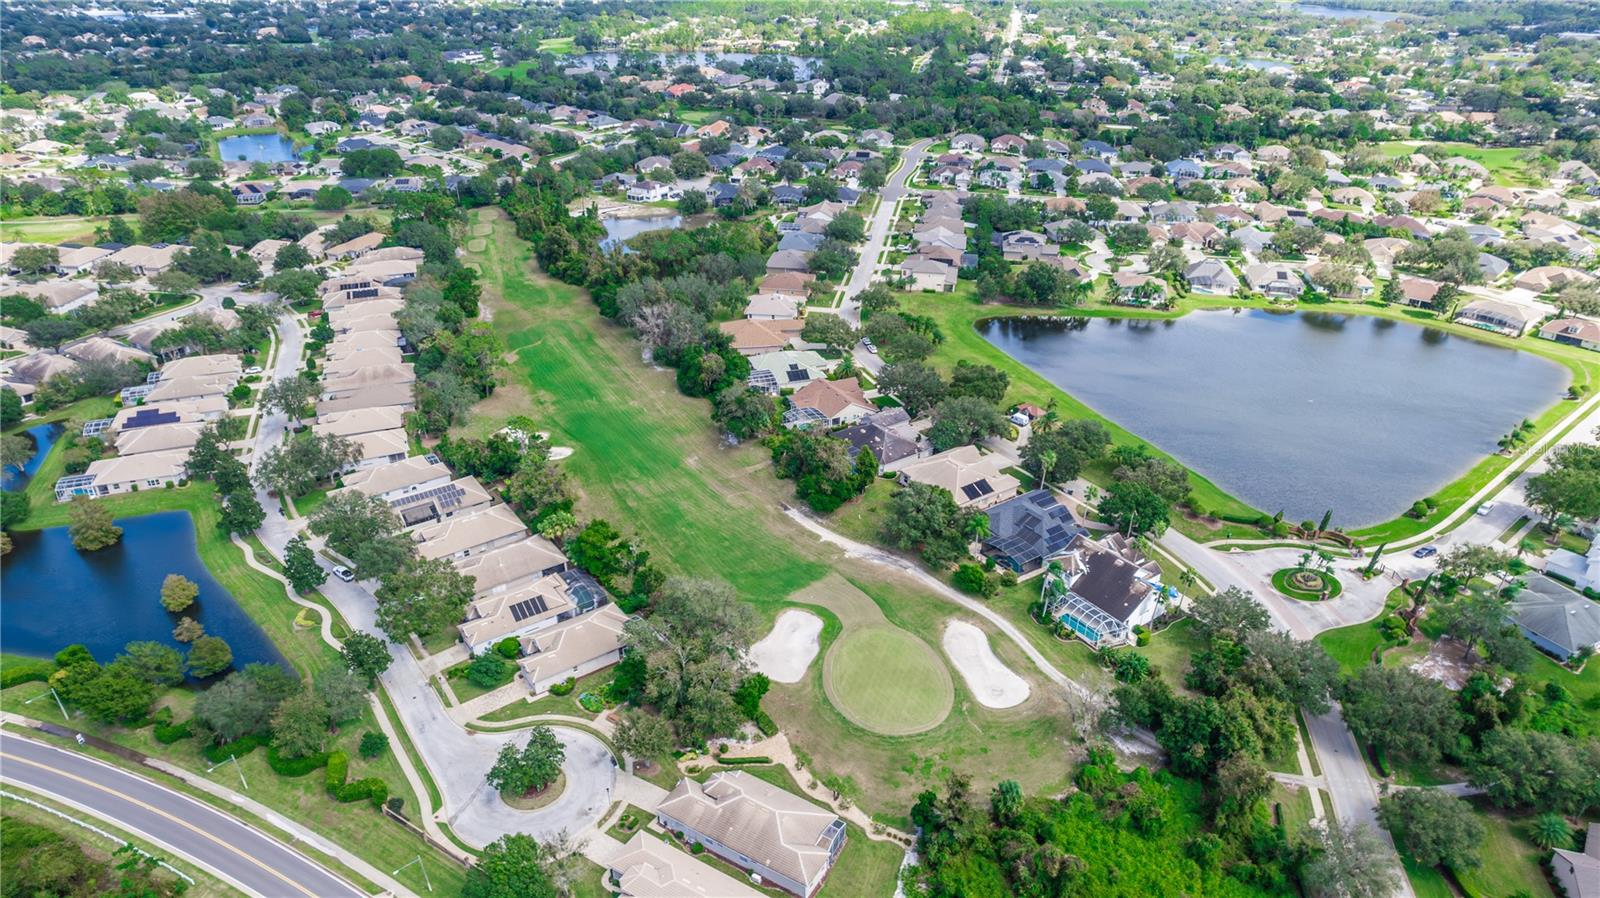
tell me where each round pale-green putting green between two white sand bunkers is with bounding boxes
[822,626,955,736]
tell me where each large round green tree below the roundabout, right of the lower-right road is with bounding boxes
[1342,666,1461,764]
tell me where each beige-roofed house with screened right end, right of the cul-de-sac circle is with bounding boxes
[656,770,845,898]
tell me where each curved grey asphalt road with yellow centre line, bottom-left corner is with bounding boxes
[0,733,368,898]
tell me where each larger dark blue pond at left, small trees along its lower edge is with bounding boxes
[0,511,286,667]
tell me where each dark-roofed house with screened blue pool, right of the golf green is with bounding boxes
[1043,533,1174,648]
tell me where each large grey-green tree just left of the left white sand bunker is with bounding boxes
[624,576,755,744]
